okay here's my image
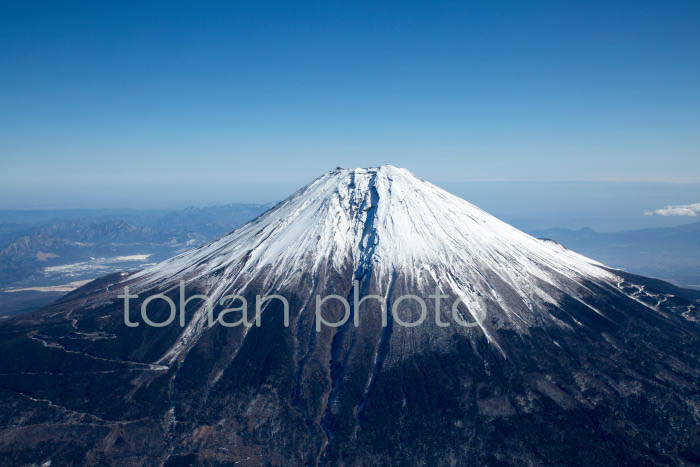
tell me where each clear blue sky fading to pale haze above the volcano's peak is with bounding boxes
[0,1,700,219]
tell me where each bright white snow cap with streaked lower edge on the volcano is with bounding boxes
[124,165,615,364]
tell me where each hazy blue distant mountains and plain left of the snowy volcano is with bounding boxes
[0,204,270,313]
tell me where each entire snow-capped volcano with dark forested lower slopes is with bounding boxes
[0,166,700,466]
